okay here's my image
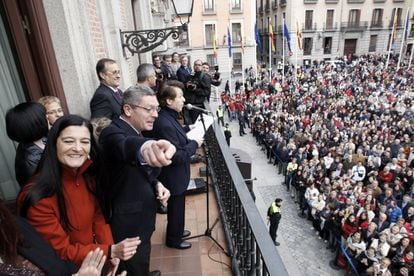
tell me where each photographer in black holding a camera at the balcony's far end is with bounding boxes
[184,59,211,124]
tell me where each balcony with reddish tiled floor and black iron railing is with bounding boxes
[151,102,288,275]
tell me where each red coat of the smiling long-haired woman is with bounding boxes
[18,160,114,266]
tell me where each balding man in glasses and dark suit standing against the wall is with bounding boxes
[90,58,122,120]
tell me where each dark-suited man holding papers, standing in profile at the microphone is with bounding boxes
[151,81,203,249]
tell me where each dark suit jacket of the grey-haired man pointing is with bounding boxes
[99,119,160,242]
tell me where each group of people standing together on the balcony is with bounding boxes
[0,53,212,276]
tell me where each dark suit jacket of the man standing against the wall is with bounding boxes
[90,83,122,120]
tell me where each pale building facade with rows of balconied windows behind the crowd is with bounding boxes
[257,0,414,65]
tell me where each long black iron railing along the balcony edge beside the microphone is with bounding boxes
[205,103,288,276]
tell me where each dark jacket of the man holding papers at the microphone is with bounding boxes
[152,107,198,195]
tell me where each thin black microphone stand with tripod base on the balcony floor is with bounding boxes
[184,109,230,256]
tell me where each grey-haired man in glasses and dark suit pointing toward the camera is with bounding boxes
[99,85,175,275]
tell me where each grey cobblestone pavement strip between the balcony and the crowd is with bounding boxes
[213,103,343,276]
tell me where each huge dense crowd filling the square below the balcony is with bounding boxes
[217,54,414,275]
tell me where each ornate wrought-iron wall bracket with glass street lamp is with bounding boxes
[120,0,194,55]
